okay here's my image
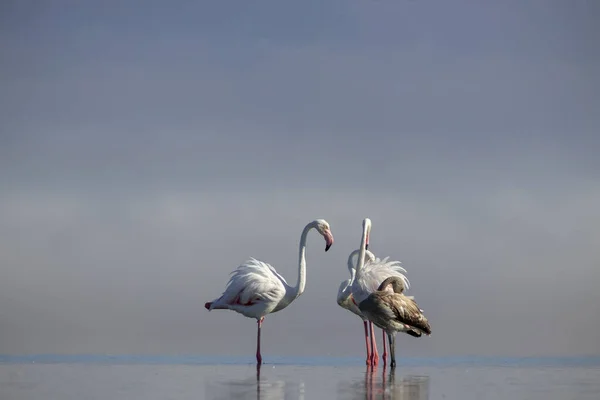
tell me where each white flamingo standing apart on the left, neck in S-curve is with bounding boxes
[204,219,333,365]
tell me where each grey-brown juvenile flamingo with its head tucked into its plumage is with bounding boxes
[358,276,431,368]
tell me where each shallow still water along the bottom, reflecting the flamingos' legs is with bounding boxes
[0,356,600,400]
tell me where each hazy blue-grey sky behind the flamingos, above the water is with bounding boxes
[0,0,600,360]
